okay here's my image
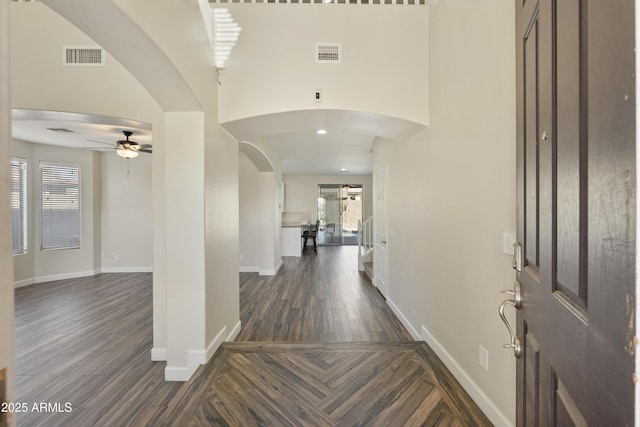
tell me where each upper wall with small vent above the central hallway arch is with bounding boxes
[219,4,428,123]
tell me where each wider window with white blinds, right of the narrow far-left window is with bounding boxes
[40,163,80,251]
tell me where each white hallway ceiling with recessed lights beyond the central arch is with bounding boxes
[222,109,424,175]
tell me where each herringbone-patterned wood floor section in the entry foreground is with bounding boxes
[180,342,489,427]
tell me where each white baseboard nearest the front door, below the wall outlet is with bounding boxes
[422,325,513,427]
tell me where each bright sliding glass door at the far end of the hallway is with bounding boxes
[318,184,362,245]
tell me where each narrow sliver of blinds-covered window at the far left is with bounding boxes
[9,159,27,255]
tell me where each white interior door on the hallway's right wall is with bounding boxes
[373,168,388,298]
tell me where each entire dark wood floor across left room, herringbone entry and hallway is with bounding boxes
[14,247,490,427]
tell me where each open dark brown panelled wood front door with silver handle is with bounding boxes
[516,0,636,426]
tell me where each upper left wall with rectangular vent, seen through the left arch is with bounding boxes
[10,2,162,126]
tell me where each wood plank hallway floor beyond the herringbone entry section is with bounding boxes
[237,246,412,342]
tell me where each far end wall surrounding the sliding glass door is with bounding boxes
[282,175,373,222]
